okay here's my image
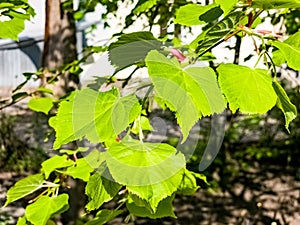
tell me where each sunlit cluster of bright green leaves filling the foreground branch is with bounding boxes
[5,0,300,225]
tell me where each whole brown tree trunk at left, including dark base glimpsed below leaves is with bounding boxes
[42,0,85,225]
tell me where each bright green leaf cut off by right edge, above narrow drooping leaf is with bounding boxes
[272,40,300,70]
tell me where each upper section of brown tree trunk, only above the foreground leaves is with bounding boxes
[42,0,78,97]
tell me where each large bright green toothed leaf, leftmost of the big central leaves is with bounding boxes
[49,89,141,149]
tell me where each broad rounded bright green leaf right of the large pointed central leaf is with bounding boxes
[217,64,277,114]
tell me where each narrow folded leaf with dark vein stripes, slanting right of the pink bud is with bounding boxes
[190,11,245,55]
